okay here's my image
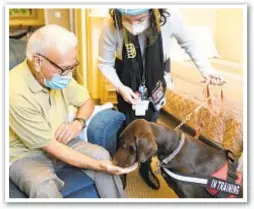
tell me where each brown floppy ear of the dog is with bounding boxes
[136,134,158,163]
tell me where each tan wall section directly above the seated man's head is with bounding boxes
[46,9,70,29]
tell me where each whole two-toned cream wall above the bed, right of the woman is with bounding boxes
[180,8,243,63]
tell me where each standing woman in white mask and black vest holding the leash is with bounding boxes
[98,8,225,189]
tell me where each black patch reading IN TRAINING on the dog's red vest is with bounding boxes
[206,178,241,195]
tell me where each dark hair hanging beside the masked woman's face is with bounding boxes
[109,9,170,30]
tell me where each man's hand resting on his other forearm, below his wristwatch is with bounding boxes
[55,120,82,144]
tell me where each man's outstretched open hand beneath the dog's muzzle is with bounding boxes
[101,160,138,175]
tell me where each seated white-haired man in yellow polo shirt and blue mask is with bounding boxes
[9,25,134,198]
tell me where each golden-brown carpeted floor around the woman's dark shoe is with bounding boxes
[125,113,180,198]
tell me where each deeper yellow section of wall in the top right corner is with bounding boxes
[215,8,243,63]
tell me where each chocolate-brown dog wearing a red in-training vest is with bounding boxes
[113,119,242,198]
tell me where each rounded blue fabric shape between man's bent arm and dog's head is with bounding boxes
[87,109,125,157]
